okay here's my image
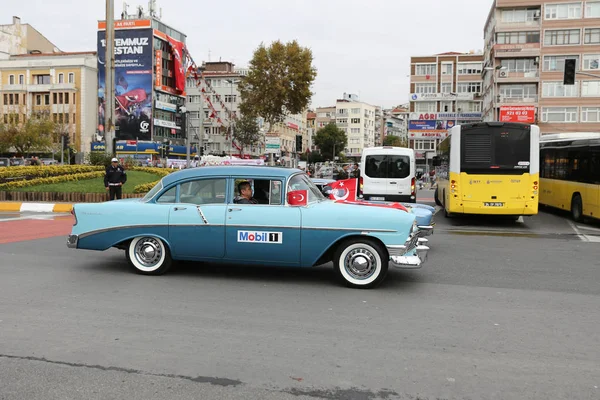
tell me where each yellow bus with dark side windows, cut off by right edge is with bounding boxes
[540,132,600,221]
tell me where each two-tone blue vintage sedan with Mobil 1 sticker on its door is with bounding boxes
[67,166,432,288]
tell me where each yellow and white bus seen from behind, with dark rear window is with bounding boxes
[433,122,540,219]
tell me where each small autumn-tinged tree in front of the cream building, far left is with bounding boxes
[0,116,55,156]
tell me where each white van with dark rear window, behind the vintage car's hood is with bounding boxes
[360,146,417,203]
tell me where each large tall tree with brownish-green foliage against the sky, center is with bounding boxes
[239,40,317,130]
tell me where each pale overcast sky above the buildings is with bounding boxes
[0,0,492,108]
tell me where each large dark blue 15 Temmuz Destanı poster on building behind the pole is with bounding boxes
[98,25,154,140]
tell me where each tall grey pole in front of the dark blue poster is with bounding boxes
[104,0,115,156]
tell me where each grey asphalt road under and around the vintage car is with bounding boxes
[0,192,600,400]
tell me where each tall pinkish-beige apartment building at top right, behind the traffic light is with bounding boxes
[483,0,600,133]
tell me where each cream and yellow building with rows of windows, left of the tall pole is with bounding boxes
[0,52,98,158]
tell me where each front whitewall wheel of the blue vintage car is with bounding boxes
[333,238,389,289]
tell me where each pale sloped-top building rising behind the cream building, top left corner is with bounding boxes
[0,17,60,60]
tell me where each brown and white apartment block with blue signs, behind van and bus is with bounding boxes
[408,52,483,169]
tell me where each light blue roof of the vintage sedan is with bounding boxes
[163,165,303,185]
